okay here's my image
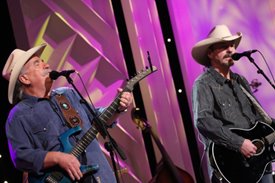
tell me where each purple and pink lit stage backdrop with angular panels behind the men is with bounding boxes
[3,0,275,182]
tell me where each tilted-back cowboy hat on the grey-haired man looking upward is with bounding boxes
[2,43,46,104]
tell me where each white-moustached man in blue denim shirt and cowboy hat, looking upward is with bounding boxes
[2,44,132,183]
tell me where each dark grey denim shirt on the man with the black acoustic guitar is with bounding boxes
[192,67,260,151]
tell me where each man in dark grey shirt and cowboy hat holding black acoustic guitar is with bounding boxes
[192,25,273,183]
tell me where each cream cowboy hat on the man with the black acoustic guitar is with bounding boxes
[192,25,242,66]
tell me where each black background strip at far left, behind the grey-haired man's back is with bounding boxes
[0,0,22,183]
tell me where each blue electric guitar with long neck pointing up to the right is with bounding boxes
[28,66,157,183]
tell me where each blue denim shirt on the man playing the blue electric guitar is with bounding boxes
[6,88,116,182]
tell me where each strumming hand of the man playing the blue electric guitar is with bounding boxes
[44,152,83,180]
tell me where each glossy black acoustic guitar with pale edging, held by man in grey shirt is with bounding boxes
[209,121,275,183]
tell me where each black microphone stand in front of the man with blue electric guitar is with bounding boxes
[65,75,127,183]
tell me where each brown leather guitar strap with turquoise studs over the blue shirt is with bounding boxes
[55,94,82,128]
